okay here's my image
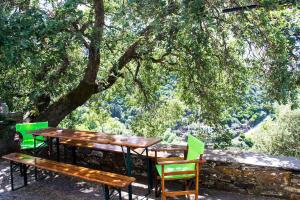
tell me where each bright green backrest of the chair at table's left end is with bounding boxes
[16,122,48,142]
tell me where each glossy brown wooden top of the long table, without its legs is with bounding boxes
[31,127,161,148]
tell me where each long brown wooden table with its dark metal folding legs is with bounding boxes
[31,127,161,200]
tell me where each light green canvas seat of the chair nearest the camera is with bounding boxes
[156,163,195,179]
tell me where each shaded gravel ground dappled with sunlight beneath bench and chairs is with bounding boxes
[0,159,278,200]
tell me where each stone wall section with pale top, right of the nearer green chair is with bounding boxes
[201,150,300,200]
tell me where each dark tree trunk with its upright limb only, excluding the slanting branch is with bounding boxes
[33,0,104,126]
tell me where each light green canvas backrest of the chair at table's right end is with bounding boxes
[187,134,205,160]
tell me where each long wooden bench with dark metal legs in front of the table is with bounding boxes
[2,153,135,199]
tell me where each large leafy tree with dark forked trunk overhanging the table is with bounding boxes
[0,0,300,126]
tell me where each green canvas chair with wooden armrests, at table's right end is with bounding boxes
[155,135,205,200]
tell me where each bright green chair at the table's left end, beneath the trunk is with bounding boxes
[16,122,48,149]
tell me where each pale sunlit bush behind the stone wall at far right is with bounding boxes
[251,105,300,157]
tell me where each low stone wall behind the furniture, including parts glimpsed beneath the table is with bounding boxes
[72,146,300,200]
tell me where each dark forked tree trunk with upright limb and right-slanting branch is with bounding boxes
[33,3,155,127]
